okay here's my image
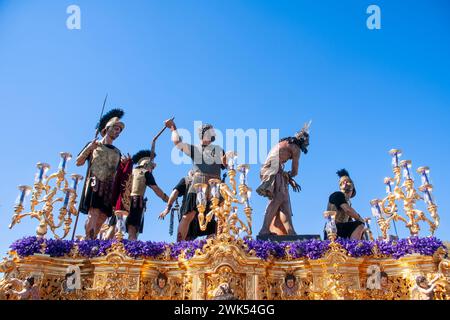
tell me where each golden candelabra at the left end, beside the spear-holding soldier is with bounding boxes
[9,152,83,239]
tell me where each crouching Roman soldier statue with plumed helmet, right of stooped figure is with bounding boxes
[324,169,365,240]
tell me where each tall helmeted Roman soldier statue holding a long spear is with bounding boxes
[76,109,125,239]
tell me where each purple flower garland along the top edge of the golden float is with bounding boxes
[10,237,445,260]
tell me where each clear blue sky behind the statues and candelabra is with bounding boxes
[0,0,450,252]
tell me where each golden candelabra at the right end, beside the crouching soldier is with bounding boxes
[370,149,439,240]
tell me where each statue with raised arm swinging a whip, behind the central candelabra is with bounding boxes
[165,119,227,241]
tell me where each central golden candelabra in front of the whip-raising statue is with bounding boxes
[194,152,252,237]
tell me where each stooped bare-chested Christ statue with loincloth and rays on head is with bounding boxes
[256,123,310,236]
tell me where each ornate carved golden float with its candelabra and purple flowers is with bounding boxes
[0,150,450,300]
